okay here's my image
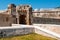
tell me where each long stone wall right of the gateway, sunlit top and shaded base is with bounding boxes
[33,8,60,24]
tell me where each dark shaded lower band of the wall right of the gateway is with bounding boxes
[33,17,60,25]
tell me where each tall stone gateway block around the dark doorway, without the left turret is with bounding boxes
[17,5,32,25]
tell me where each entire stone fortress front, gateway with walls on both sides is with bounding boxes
[0,4,60,26]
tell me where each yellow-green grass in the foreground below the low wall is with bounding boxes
[0,33,57,40]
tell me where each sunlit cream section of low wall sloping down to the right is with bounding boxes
[35,26,60,39]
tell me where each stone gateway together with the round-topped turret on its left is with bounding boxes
[8,4,32,25]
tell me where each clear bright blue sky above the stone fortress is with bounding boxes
[0,0,60,10]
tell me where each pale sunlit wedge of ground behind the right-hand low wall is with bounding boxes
[34,24,60,34]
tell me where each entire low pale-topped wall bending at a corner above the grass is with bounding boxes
[0,24,60,39]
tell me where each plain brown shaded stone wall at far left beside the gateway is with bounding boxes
[0,14,12,27]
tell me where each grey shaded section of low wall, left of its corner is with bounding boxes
[0,27,34,37]
